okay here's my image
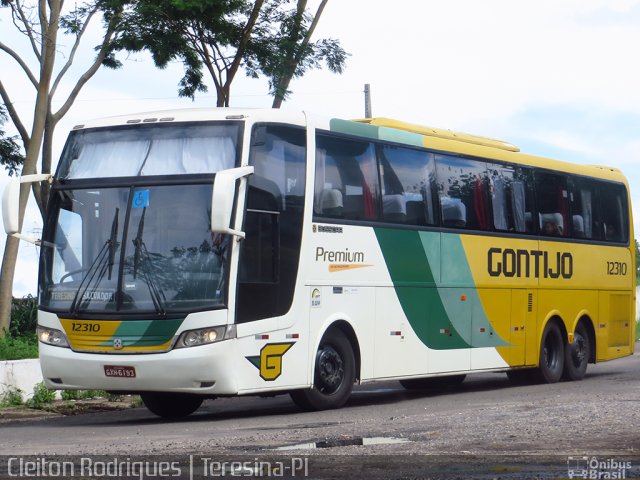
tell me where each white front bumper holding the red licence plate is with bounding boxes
[39,340,238,396]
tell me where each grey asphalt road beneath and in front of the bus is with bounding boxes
[0,345,640,478]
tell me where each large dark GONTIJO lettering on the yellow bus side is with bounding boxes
[487,247,573,278]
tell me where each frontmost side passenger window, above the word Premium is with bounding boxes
[314,134,379,220]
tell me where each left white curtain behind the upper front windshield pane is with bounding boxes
[68,140,151,178]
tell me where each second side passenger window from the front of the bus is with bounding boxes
[380,145,436,225]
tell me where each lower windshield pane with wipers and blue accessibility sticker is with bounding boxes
[40,183,228,315]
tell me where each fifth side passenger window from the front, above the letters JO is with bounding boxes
[536,172,571,237]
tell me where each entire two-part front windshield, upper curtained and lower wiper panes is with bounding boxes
[40,122,242,316]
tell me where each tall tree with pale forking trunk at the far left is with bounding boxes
[0,0,122,335]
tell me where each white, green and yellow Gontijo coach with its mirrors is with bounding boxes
[3,109,635,418]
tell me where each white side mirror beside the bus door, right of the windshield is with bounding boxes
[211,167,253,238]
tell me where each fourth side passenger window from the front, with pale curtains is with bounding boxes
[487,163,535,233]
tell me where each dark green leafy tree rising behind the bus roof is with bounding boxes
[113,0,346,107]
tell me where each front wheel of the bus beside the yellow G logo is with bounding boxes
[291,329,356,411]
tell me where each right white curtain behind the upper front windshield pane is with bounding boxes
[138,137,236,175]
